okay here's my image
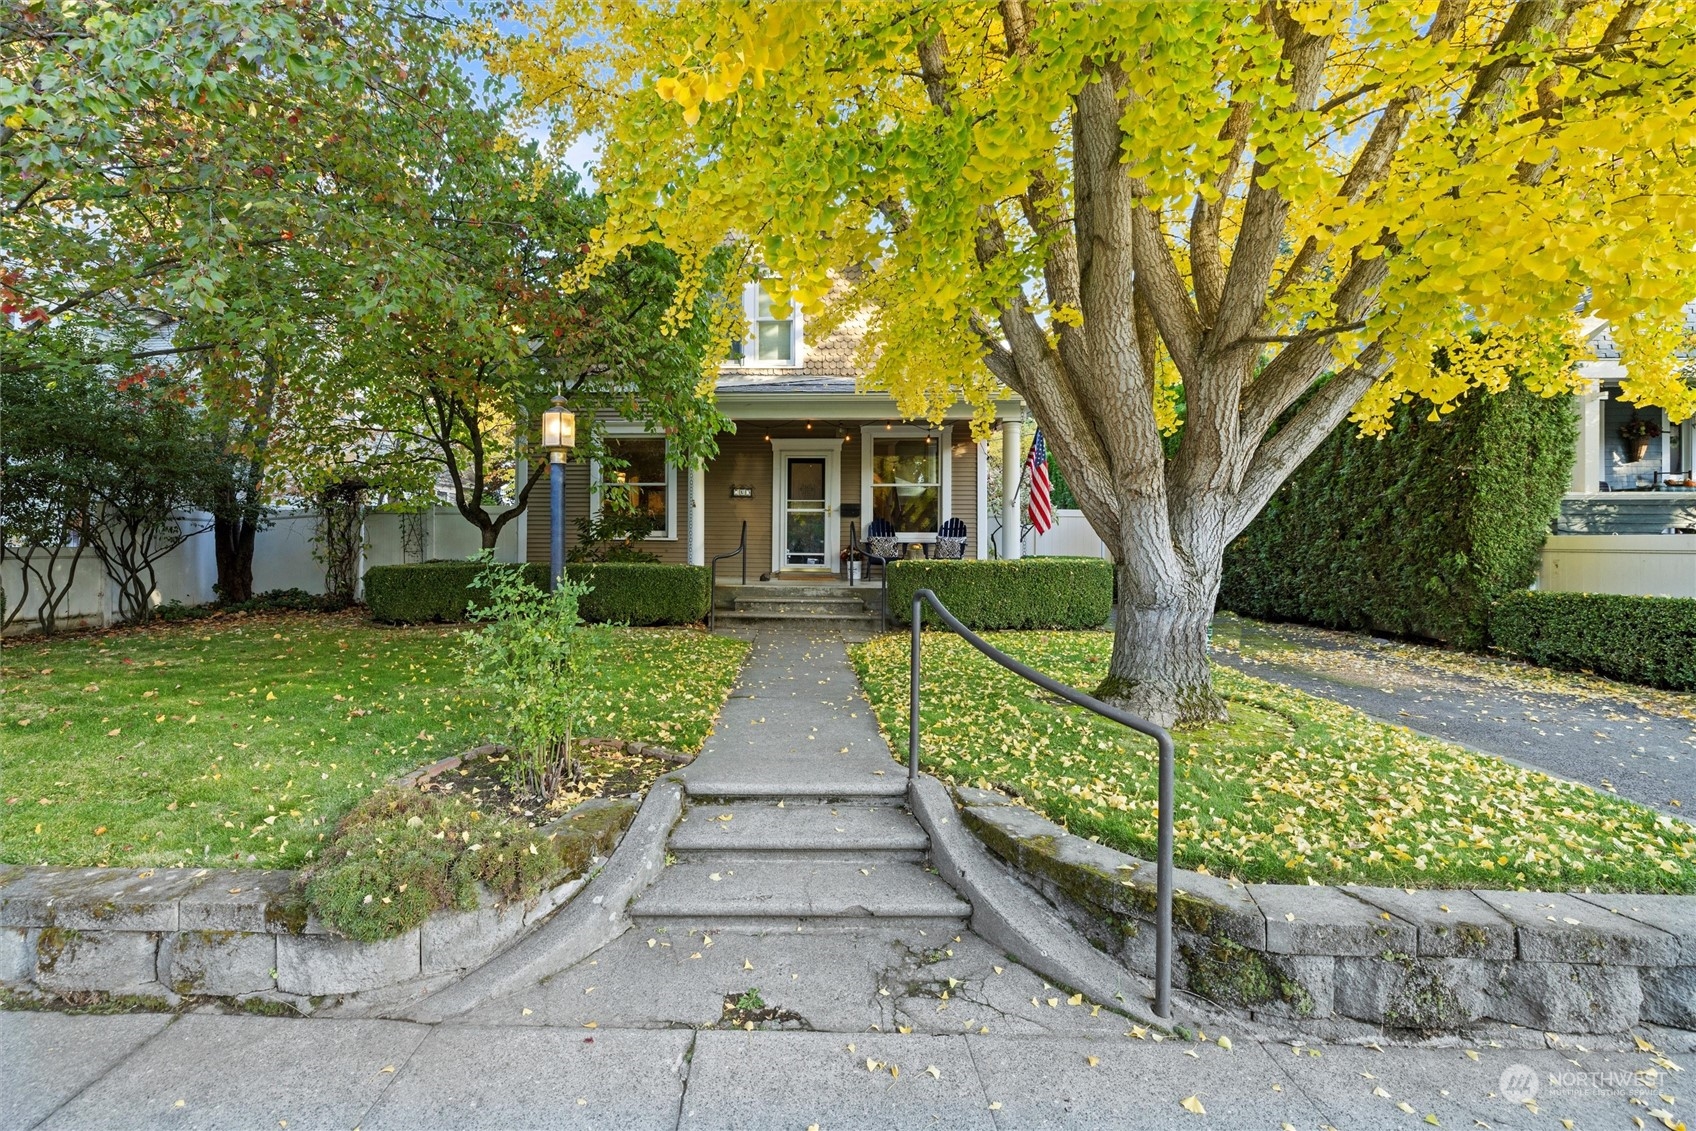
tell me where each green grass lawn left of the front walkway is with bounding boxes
[0,614,748,868]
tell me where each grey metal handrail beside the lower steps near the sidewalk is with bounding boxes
[907,588,1174,1021]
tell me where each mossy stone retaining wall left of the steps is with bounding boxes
[0,799,638,1012]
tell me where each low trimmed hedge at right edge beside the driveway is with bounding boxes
[1489,592,1696,692]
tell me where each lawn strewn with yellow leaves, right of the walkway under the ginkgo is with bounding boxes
[851,632,1696,892]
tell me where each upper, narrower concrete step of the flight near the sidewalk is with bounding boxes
[672,799,929,865]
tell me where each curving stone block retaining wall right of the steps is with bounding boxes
[955,788,1696,1033]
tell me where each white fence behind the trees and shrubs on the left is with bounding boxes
[0,507,524,632]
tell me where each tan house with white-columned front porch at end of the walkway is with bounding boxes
[524,285,1024,580]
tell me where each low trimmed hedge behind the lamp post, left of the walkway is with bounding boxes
[365,561,712,624]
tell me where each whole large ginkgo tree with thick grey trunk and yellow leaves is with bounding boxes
[490,0,1696,724]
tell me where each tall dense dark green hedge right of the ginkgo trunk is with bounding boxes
[1219,385,1577,648]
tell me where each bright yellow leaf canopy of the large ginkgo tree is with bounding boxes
[482,0,1696,431]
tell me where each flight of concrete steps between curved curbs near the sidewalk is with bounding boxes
[631,794,972,934]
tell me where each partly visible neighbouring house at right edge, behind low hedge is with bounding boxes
[1538,302,1696,597]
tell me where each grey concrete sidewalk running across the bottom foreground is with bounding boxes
[0,999,1691,1131]
